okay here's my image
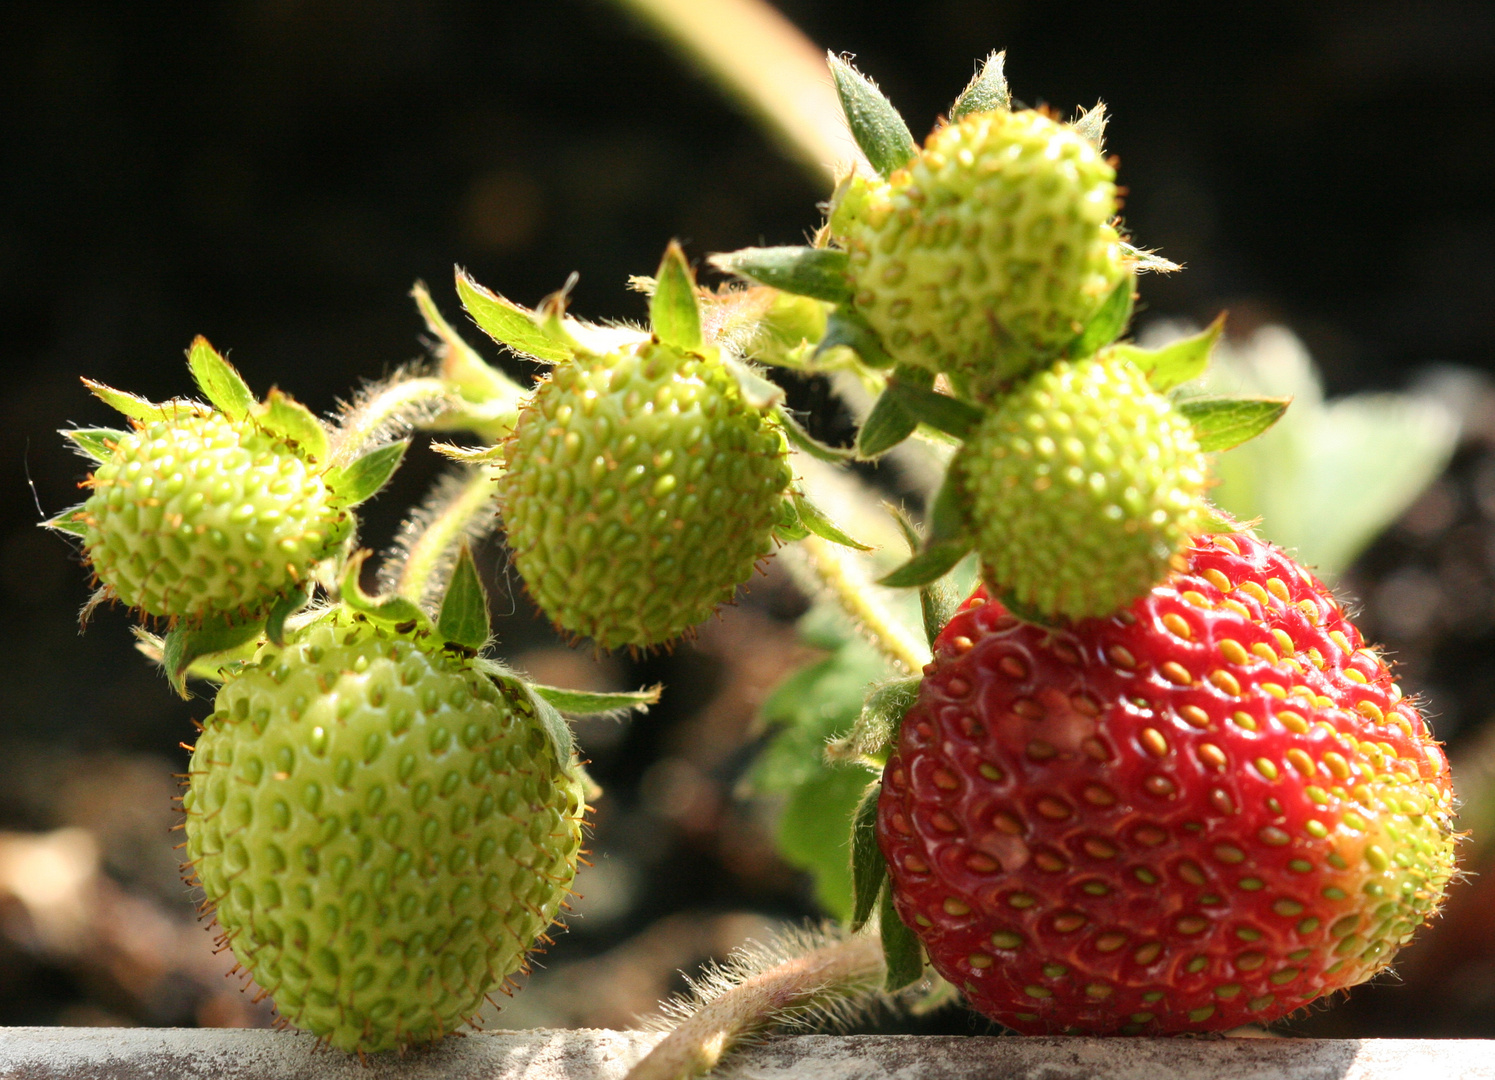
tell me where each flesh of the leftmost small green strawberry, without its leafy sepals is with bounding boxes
[70,402,353,622]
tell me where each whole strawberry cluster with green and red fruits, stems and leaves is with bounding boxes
[46,18,1453,1080]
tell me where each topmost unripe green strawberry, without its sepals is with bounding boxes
[830,109,1127,395]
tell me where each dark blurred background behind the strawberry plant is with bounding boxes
[0,0,1495,1035]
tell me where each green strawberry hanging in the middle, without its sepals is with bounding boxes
[499,340,791,649]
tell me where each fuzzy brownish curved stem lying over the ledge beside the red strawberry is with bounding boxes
[625,933,884,1080]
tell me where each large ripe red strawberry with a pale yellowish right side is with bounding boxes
[878,534,1453,1034]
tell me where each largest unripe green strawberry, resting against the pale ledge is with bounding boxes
[184,610,583,1052]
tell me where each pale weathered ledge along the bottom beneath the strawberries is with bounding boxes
[0,1028,1495,1080]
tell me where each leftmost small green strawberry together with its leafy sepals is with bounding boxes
[46,337,404,628]
